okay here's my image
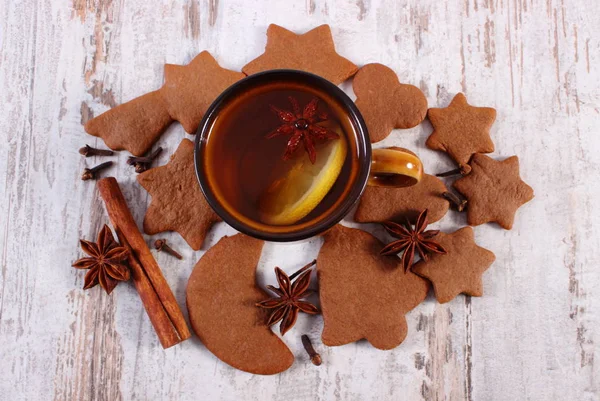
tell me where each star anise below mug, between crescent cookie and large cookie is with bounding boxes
[256,260,319,335]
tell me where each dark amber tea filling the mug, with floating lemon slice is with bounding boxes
[204,82,358,231]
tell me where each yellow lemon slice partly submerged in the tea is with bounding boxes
[259,133,347,226]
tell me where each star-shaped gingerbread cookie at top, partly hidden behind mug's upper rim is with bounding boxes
[242,24,357,85]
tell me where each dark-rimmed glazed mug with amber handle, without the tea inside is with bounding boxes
[194,70,423,242]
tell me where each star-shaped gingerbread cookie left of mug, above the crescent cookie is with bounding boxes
[137,139,220,251]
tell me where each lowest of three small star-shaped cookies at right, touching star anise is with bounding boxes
[412,227,496,304]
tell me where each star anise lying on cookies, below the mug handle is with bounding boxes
[380,209,446,271]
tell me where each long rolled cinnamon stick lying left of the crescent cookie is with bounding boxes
[98,177,191,348]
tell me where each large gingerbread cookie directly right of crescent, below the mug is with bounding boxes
[317,224,429,349]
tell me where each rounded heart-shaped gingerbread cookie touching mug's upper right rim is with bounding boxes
[352,63,427,142]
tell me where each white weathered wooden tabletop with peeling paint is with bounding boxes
[0,0,600,401]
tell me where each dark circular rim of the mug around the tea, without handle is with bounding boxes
[194,69,371,242]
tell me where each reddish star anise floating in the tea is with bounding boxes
[267,96,340,164]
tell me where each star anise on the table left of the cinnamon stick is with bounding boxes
[73,224,130,294]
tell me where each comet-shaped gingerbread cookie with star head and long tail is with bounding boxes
[85,51,245,156]
